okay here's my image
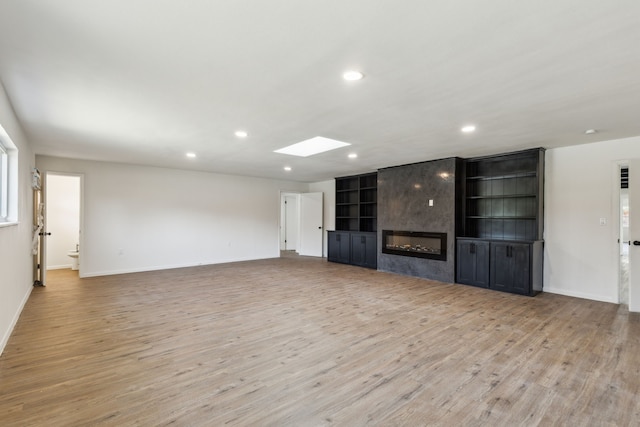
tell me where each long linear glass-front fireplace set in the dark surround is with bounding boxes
[382,230,447,261]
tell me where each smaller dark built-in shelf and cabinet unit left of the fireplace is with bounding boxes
[328,173,378,268]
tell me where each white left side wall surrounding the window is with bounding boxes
[0,85,35,353]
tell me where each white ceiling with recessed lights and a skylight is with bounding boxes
[0,0,640,182]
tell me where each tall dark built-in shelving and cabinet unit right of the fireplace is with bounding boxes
[456,149,544,295]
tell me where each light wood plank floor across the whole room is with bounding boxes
[0,257,640,426]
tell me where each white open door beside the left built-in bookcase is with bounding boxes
[298,192,324,257]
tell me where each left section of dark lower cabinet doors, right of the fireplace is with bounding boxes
[457,240,489,288]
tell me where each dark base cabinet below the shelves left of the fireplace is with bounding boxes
[327,231,378,269]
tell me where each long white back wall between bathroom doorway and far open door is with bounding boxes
[36,156,308,277]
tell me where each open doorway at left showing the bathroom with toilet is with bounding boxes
[44,172,83,271]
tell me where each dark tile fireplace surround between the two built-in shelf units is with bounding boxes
[378,158,462,283]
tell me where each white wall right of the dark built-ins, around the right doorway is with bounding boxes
[544,137,640,303]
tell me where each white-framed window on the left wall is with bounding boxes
[0,126,18,226]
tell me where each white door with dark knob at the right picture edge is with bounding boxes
[629,159,640,312]
